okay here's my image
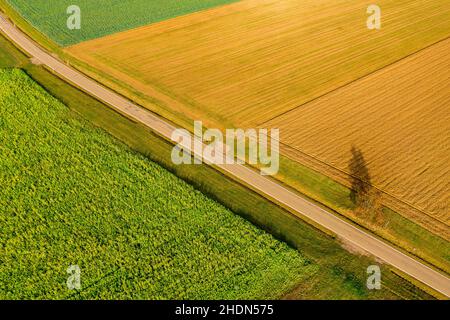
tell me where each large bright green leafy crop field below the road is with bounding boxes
[0,69,312,299]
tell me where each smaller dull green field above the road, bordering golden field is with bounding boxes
[7,0,239,46]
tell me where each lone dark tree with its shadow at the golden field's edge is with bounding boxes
[348,146,381,220]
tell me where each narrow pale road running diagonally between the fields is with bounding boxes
[0,15,450,297]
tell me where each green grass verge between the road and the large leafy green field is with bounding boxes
[0,31,431,299]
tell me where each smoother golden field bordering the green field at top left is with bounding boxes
[68,0,450,127]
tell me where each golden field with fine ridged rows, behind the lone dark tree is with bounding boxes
[264,39,450,237]
